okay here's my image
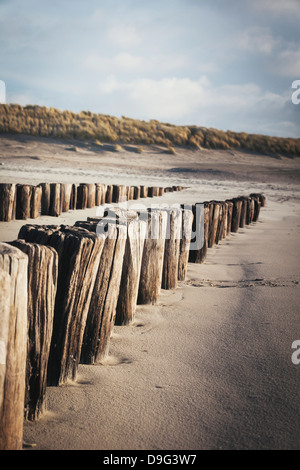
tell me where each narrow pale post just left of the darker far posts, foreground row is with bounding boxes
[178,208,193,281]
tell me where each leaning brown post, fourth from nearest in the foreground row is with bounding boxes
[81,220,127,364]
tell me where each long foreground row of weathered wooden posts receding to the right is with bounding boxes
[0,194,265,450]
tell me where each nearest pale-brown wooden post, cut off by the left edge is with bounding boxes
[0,243,28,450]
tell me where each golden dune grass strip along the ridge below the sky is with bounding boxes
[0,104,300,156]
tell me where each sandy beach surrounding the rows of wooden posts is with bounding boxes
[0,136,300,450]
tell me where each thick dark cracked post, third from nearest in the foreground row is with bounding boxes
[19,225,105,385]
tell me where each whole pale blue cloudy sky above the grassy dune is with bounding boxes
[0,0,300,138]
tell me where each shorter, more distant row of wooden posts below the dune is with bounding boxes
[0,183,183,222]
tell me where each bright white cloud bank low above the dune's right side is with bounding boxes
[90,75,299,136]
